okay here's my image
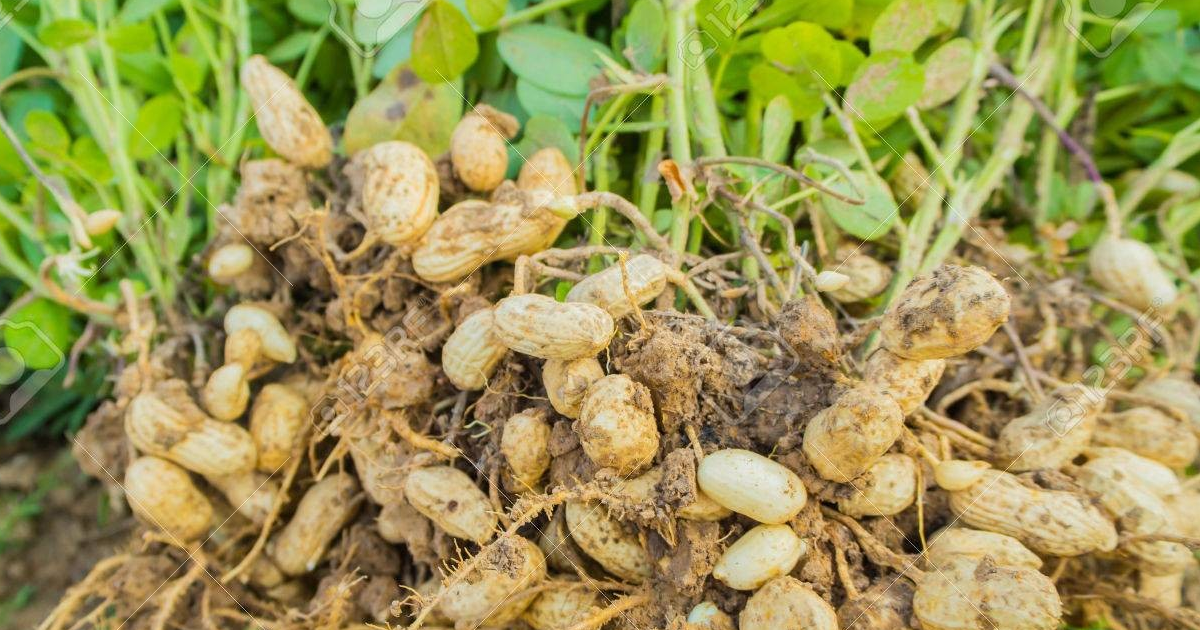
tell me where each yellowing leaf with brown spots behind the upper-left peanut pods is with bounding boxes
[342,66,462,155]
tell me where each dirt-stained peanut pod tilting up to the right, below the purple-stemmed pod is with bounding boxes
[992,385,1104,473]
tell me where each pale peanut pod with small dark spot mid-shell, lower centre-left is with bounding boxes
[404,466,497,544]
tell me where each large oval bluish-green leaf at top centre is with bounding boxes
[497,24,607,96]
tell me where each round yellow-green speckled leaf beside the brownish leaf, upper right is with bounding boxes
[846,50,925,124]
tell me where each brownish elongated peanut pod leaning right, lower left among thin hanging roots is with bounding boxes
[270,473,361,576]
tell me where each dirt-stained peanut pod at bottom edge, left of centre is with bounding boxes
[438,536,546,628]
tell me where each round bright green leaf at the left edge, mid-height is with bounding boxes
[0,298,74,370]
